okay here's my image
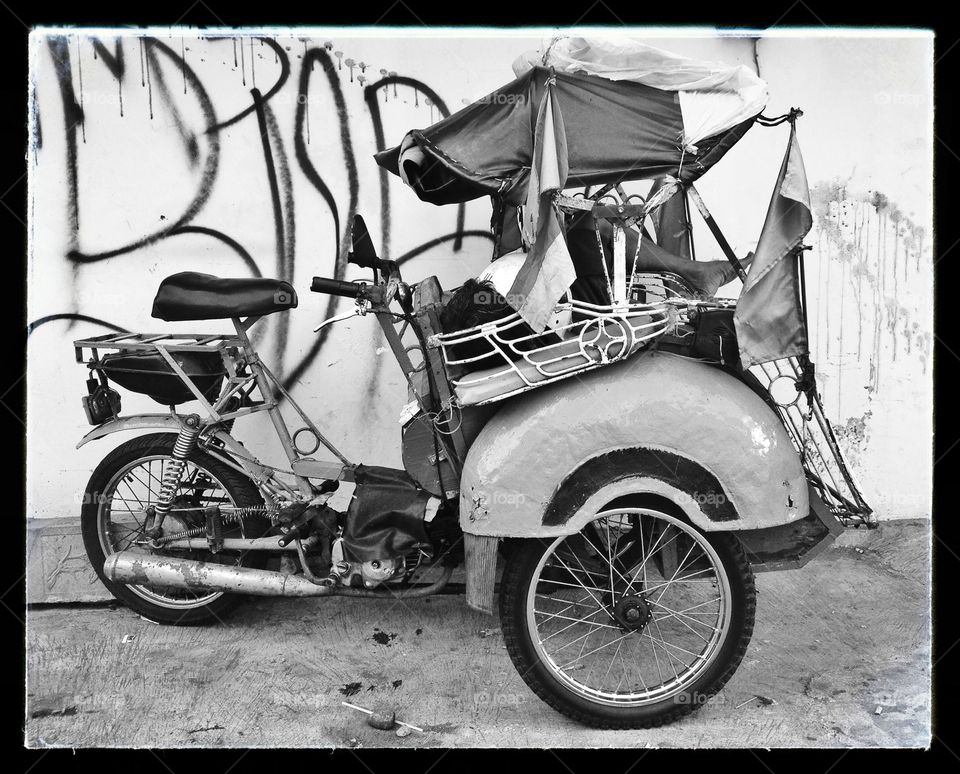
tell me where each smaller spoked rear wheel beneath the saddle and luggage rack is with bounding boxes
[81,434,268,624]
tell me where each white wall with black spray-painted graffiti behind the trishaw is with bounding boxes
[28,30,933,517]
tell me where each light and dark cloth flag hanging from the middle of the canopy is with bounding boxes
[507,75,577,333]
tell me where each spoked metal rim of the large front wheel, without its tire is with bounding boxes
[526,508,732,707]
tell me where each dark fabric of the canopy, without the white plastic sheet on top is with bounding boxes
[375,67,753,204]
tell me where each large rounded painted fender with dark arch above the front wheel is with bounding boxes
[460,352,809,538]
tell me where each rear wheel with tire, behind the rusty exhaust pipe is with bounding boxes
[80,433,269,625]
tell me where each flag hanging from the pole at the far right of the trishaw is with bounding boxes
[733,118,813,368]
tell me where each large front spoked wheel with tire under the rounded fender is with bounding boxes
[500,508,756,728]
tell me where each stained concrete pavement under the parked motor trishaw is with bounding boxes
[25,520,930,748]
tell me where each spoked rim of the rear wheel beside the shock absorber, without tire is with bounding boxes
[97,455,243,611]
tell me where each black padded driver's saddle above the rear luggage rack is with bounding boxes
[151,271,297,322]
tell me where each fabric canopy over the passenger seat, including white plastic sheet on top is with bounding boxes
[376,38,767,204]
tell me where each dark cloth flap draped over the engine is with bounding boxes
[343,465,430,562]
